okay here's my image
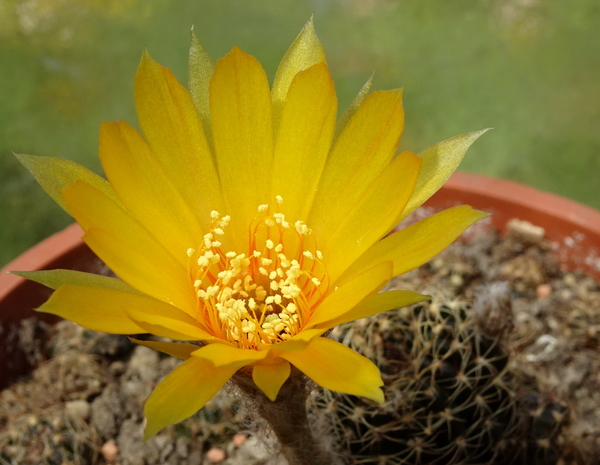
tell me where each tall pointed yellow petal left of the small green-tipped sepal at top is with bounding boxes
[134,52,223,228]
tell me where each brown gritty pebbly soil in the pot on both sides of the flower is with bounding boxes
[0,216,600,465]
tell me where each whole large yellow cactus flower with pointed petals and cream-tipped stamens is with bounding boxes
[14,21,485,437]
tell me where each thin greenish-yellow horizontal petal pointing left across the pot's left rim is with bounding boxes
[11,270,140,294]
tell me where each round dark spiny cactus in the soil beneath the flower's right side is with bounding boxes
[311,300,568,465]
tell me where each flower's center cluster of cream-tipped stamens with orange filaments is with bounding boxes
[187,196,329,349]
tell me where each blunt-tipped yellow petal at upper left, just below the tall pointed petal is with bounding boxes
[100,121,204,257]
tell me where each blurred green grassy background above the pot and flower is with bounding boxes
[0,0,600,265]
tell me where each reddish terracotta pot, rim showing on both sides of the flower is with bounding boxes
[0,173,600,388]
